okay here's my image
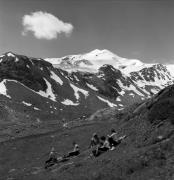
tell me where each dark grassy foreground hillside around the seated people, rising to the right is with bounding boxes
[0,82,174,180]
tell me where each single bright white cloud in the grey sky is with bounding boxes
[22,11,74,40]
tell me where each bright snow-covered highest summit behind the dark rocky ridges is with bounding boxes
[45,49,147,73]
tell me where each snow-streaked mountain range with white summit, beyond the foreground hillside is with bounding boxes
[0,49,174,123]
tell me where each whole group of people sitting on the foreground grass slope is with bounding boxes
[46,129,120,167]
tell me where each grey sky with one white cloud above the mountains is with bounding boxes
[0,0,174,63]
